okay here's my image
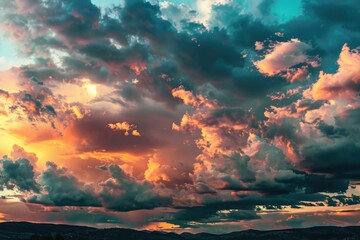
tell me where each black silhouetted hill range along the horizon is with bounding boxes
[0,222,360,240]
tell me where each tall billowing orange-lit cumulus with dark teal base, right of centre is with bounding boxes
[173,85,304,196]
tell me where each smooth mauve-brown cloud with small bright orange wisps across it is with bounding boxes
[67,106,167,154]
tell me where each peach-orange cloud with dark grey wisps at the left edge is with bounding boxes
[0,72,84,134]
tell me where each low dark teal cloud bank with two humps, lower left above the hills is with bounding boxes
[28,160,172,212]
